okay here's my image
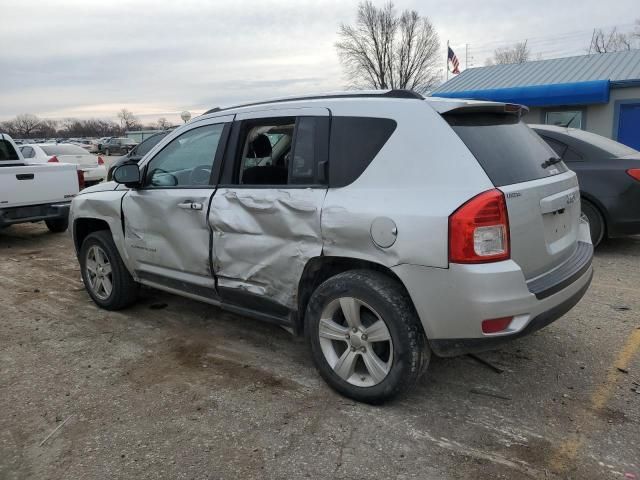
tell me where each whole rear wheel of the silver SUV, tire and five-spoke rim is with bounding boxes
[305,270,430,403]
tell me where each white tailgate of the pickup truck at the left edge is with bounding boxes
[0,164,78,208]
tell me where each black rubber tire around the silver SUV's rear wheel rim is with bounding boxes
[305,270,431,404]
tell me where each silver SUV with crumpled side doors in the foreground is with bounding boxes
[70,90,593,403]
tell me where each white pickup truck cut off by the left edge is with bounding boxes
[0,133,84,232]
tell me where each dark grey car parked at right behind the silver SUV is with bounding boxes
[531,125,640,245]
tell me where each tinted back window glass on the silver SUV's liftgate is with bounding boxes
[443,112,567,187]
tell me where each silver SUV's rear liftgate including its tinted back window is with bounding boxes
[443,104,582,280]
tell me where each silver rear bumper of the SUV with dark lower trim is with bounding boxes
[393,243,593,356]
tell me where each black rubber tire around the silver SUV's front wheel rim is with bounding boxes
[80,230,140,310]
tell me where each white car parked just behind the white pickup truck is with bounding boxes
[20,143,107,186]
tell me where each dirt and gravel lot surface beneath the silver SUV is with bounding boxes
[0,224,640,480]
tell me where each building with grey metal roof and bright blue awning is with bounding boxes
[431,50,640,150]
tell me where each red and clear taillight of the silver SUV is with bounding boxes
[449,189,510,263]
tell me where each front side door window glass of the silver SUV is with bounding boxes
[145,123,224,188]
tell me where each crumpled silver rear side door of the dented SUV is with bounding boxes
[209,108,329,309]
